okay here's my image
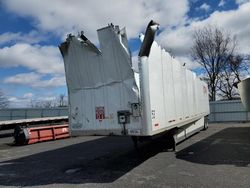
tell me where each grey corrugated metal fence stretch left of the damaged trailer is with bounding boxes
[0,107,68,121]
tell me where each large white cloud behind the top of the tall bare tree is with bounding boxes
[157,3,250,62]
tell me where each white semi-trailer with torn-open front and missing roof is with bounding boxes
[59,21,209,147]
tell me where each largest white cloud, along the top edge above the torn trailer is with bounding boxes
[3,0,189,41]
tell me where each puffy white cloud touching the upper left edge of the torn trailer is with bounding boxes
[0,43,64,74]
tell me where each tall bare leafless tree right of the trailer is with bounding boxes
[191,26,237,101]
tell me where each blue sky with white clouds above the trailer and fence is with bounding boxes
[0,0,250,107]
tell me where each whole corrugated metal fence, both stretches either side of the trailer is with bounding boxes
[0,100,250,122]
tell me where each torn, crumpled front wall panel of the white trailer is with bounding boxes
[60,25,141,134]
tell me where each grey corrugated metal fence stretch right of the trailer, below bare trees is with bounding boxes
[209,100,250,122]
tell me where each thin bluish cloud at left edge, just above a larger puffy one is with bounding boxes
[0,30,46,45]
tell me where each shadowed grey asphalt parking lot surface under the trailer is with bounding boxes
[0,123,250,188]
